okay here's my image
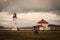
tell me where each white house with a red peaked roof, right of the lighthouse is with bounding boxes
[36,19,50,30]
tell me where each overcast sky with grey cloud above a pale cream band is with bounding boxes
[0,0,60,27]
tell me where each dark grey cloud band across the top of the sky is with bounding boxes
[2,0,60,12]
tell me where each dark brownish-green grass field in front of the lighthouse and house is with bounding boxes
[0,30,60,40]
